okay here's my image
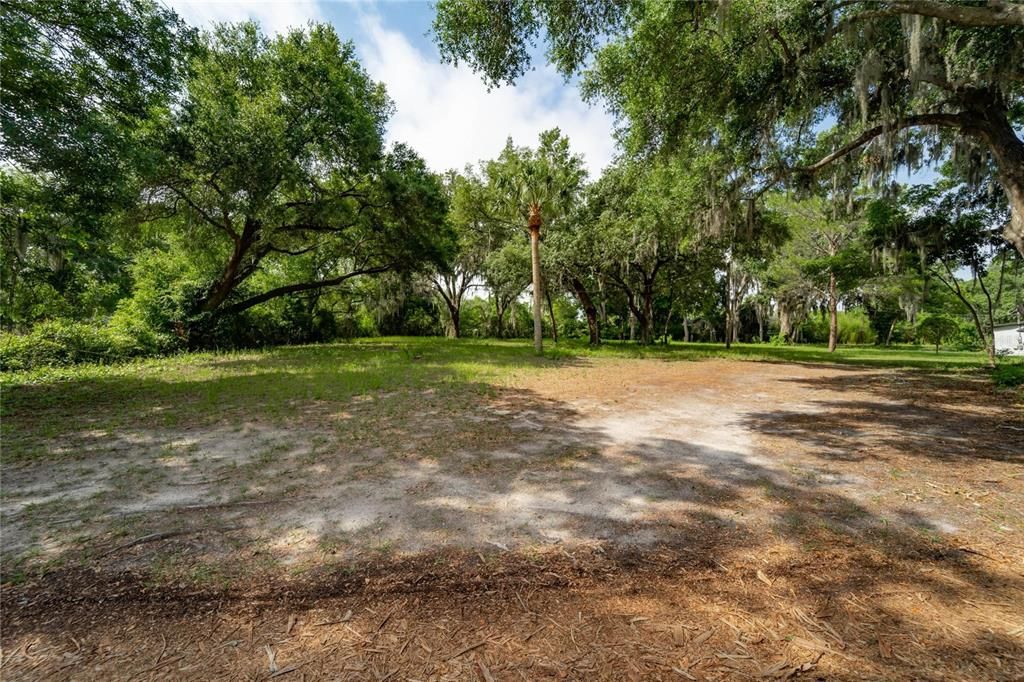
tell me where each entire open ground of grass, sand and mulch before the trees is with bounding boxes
[0,340,1024,680]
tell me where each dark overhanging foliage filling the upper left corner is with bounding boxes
[0,0,195,228]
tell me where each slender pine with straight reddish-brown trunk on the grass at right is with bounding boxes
[776,197,866,352]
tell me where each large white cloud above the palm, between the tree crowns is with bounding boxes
[356,14,615,177]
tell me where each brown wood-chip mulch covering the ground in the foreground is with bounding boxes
[0,543,1024,681]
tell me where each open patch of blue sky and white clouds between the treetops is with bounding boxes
[164,0,615,178]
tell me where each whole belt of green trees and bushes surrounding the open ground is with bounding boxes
[0,0,1024,372]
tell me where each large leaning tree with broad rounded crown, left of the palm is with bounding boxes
[140,24,450,336]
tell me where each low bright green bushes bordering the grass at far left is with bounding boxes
[0,321,163,372]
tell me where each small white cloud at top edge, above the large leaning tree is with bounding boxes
[164,0,324,36]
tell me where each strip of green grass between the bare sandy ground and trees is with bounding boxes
[0,338,1007,463]
